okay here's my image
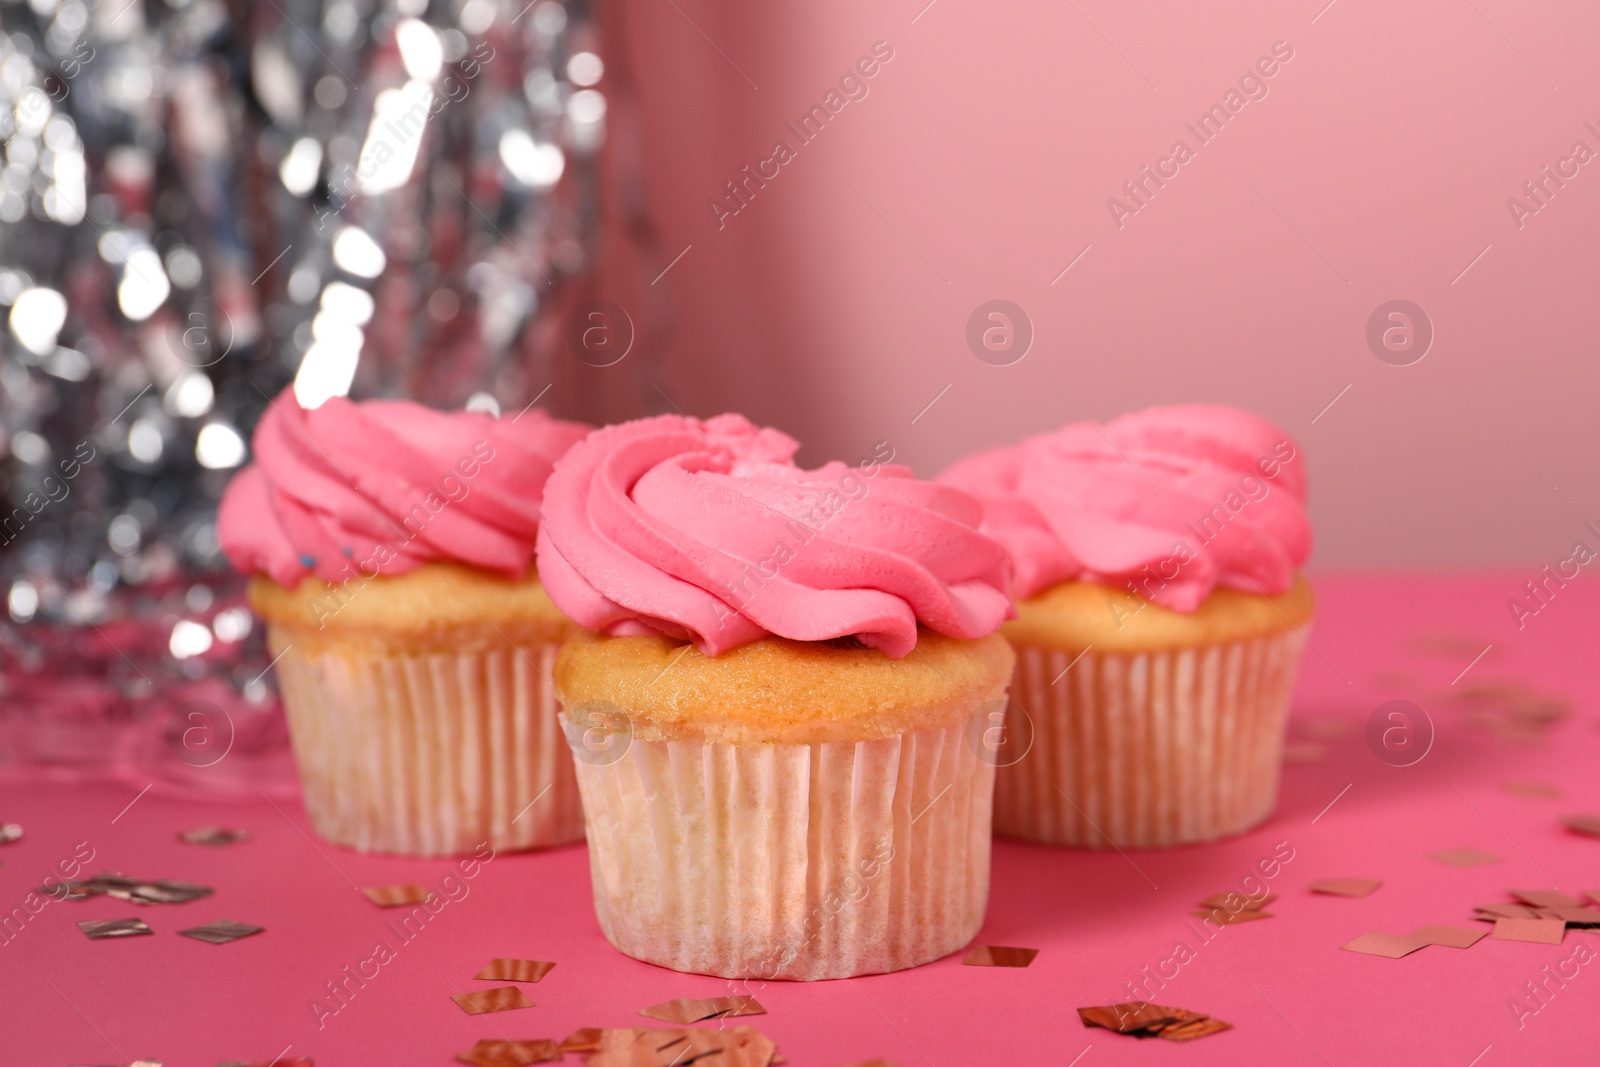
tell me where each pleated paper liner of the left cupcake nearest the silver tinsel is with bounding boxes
[272,629,584,856]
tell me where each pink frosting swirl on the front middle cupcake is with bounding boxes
[539,414,1013,657]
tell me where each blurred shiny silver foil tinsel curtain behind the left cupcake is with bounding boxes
[0,0,646,783]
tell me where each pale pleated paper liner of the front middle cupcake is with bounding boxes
[573,725,994,981]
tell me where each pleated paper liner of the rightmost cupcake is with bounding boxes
[994,629,1304,848]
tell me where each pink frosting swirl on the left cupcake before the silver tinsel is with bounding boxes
[218,389,589,587]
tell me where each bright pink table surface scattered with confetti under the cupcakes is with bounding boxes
[0,574,1600,1067]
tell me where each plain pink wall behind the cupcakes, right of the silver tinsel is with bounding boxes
[601,0,1600,566]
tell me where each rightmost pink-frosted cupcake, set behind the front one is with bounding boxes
[939,406,1315,848]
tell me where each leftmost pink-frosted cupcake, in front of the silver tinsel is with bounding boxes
[218,390,589,856]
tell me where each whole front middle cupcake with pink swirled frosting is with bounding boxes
[539,414,1013,979]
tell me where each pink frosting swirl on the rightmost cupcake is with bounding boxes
[939,405,1312,611]
